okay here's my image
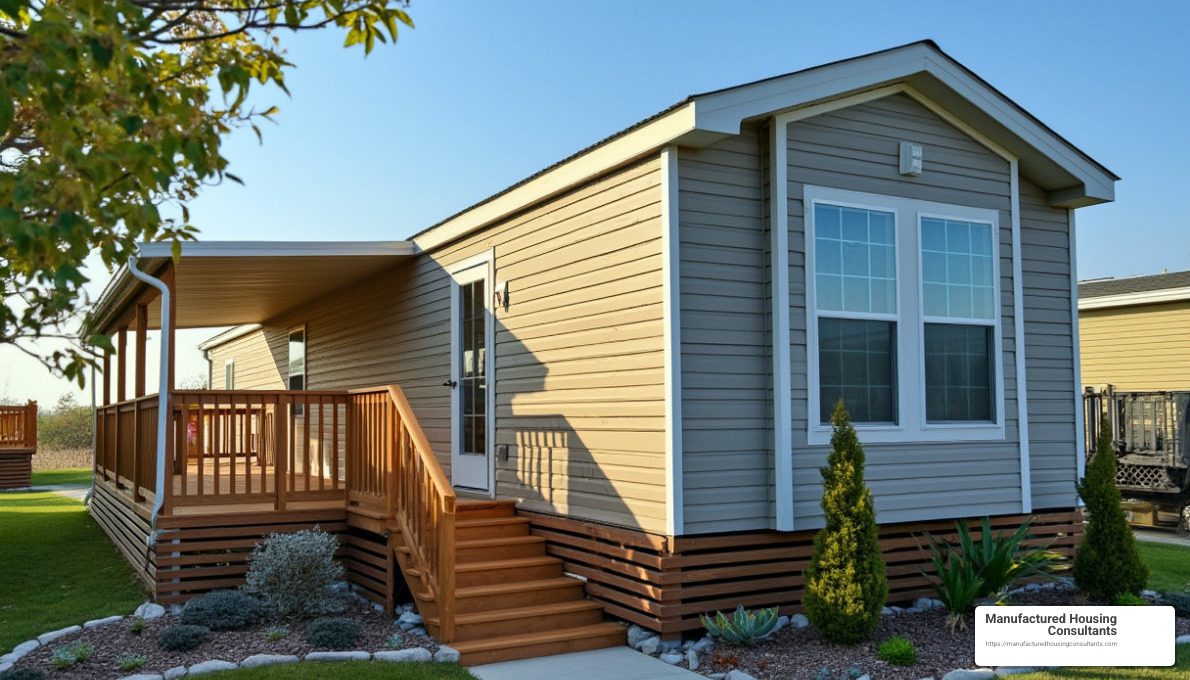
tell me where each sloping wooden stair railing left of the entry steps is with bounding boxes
[347,385,456,642]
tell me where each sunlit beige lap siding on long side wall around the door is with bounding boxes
[204,157,665,532]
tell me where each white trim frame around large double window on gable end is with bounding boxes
[803,185,1006,445]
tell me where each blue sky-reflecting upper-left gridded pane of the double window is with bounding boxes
[814,204,896,314]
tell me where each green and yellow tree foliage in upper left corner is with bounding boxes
[0,0,413,383]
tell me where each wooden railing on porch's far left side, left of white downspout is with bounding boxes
[95,394,158,501]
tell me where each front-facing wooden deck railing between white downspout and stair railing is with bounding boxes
[167,389,349,510]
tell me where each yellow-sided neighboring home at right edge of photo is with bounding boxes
[1078,272,1190,392]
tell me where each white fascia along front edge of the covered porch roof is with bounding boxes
[138,241,417,260]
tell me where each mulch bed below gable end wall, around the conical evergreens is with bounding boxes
[699,591,1190,680]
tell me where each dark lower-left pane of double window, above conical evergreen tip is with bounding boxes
[819,318,896,423]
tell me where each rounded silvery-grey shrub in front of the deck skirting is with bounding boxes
[246,528,343,617]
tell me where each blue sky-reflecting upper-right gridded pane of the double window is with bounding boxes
[921,218,996,319]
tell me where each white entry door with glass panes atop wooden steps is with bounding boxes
[447,255,495,493]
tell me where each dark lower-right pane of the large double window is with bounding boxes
[926,324,995,423]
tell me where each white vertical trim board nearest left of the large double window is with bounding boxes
[769,117,794,531]
